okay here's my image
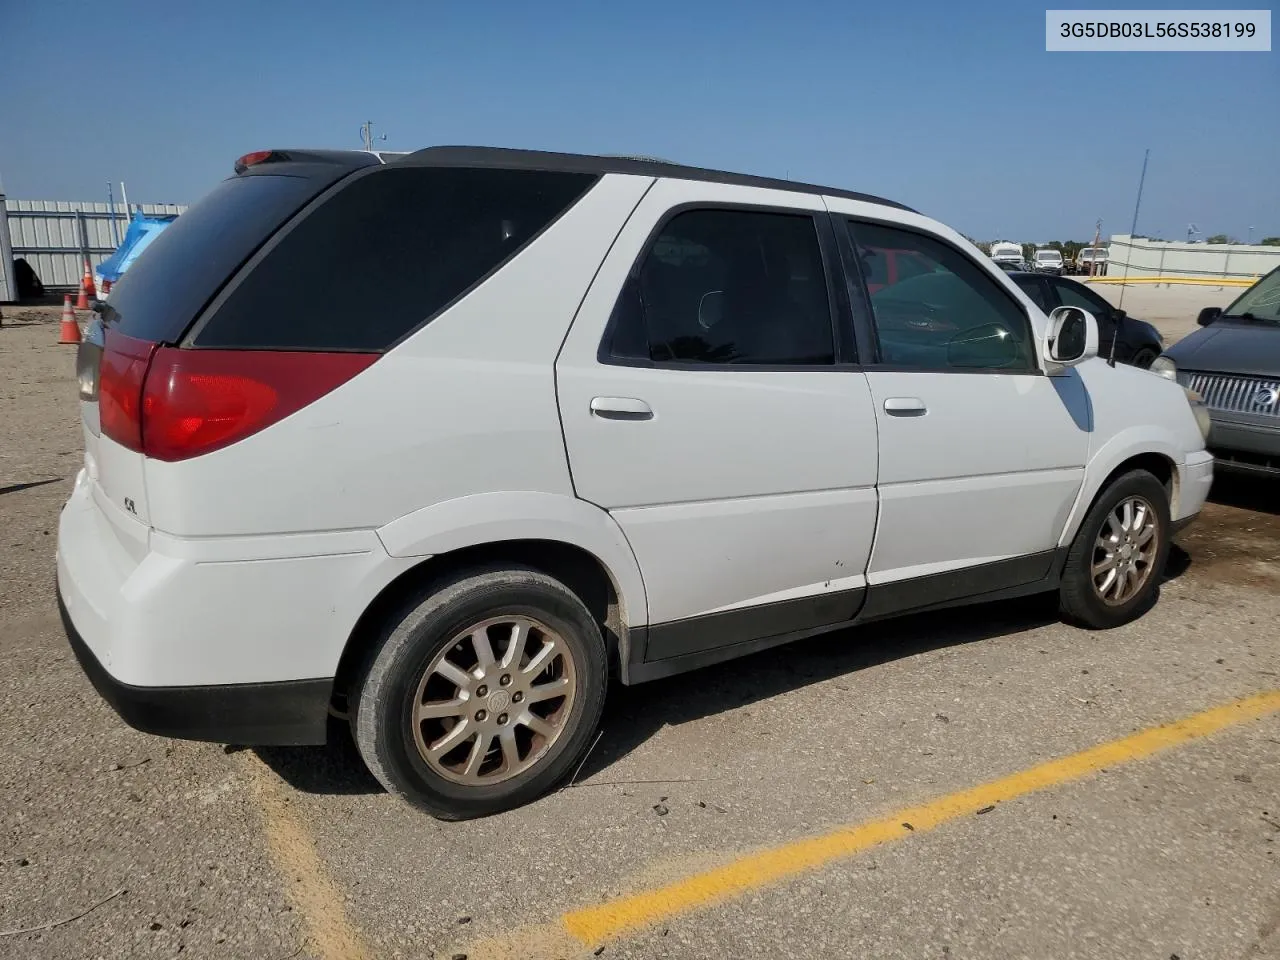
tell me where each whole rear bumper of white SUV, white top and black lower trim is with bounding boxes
[58,471,417,745]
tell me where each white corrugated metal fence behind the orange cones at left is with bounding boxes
[0,195,187,302]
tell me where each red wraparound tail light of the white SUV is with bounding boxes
[99,333,379,461]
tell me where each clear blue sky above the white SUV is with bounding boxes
[0,0,1280,241]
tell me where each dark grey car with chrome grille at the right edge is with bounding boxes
[1156,268,1280,476]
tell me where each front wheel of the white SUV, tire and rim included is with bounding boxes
[1060,470,1171,630]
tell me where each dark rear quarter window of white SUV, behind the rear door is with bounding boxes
[195,166,595,351]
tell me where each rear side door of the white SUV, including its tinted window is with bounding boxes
[557,180,877,660]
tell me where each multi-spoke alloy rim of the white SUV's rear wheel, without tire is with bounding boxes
[412,616,577,786]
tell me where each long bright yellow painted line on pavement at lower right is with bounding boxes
[558,690,1280,955]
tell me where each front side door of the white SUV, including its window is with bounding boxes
[828,212,1089,617]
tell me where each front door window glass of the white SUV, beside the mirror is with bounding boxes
[849,223,1036,370]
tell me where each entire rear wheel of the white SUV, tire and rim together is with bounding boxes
[352,567,608,820]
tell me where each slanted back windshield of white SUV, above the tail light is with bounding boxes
[104,175,332,343]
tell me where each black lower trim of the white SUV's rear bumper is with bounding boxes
[58,589,333,746]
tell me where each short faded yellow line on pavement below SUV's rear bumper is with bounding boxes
[241,754,372,960]
